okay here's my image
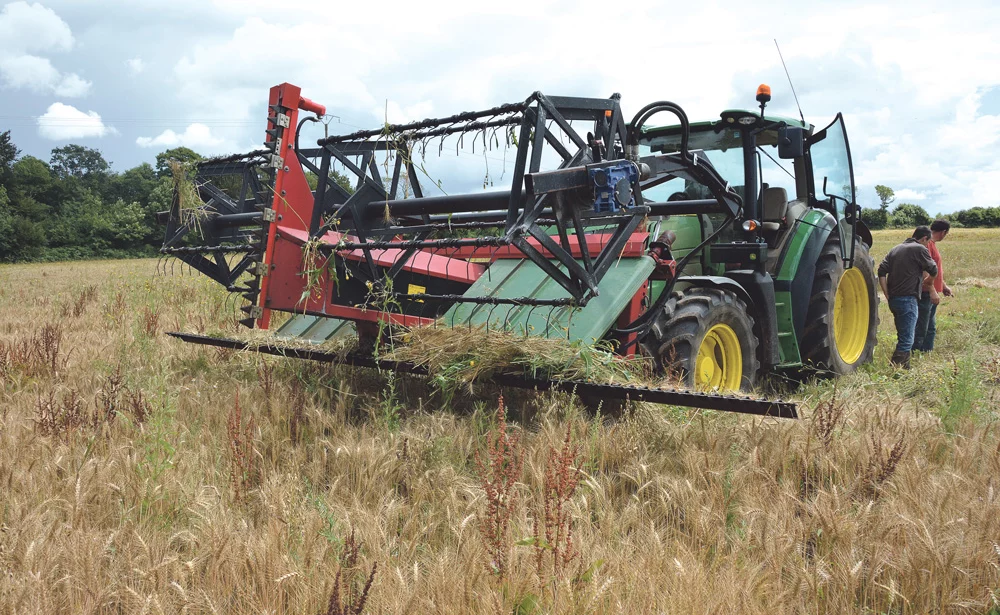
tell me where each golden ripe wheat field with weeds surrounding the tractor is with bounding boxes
[0,229,1000,615]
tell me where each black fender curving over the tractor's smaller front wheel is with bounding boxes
[677,270,780,370]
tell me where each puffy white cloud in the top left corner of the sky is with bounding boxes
[0,2,91,98]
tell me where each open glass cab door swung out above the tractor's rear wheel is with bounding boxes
[808,113,859,267]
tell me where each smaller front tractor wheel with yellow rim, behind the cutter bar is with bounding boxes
[642,288,760,391]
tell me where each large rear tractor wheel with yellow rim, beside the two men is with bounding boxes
[801,229,878,376]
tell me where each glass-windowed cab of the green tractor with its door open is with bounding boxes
[640,95,871,273]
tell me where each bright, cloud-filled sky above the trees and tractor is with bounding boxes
[0,0,1000,214]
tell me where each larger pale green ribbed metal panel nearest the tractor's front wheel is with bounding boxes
[442,256,655,344]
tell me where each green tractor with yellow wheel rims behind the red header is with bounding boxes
[640,88,878,390]
